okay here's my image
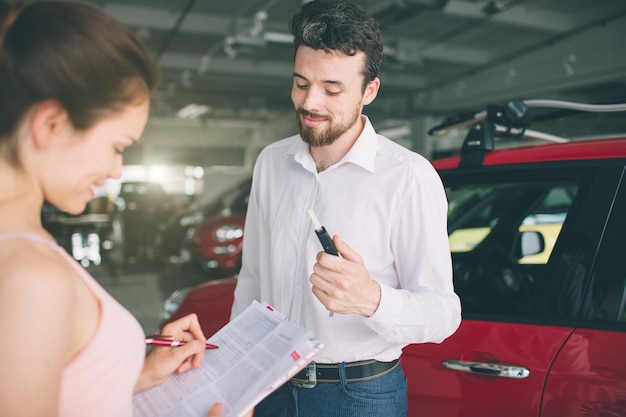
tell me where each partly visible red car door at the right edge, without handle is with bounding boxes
[541,166,626,417]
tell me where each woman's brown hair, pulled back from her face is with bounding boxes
[0,0,157,162]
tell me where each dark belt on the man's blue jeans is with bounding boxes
[291,359,400,388]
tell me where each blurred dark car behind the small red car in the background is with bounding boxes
[156,177,252,267]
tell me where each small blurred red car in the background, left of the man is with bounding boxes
[182,212,246,278]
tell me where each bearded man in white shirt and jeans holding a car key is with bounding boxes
[232,0,461,417]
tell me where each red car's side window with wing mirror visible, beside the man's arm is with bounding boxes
[444,175,579,320]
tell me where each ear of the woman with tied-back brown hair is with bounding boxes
[31,100,71,148]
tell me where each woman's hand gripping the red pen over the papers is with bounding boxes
[135,314,206,392]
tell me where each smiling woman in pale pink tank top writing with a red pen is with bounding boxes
[0,0,244,417]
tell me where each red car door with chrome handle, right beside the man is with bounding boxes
[402,163,617,417]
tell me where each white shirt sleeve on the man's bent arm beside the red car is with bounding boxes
[366,170,461,344]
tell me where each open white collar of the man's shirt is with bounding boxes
[287,115,378,172]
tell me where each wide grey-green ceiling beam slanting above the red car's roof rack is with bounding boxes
[415,15,626,111]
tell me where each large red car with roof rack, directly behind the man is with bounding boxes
[160,103,626,417]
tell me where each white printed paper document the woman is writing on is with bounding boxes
[133,301,322,417]
